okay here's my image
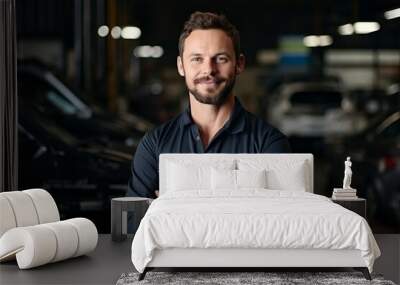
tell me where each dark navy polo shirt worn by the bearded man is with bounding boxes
[127,98,290,198]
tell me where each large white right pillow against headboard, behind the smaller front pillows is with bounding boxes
[237,159,311,191]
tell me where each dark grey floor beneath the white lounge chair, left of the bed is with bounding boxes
[0,234,134,285]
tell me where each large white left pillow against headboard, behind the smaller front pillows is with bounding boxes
[166,160,235,191]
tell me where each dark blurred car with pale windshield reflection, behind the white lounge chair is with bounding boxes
[18,63,152,232]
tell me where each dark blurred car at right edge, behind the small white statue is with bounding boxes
[327,110,400,232]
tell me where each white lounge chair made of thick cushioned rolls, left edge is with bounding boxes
[0,189,98,269]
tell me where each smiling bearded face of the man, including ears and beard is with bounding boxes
[177,29,244,105]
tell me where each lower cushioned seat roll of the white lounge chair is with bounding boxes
[0,218,98,269]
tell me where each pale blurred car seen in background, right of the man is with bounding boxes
[268,82,366,137]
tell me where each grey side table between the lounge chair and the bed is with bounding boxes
[111,197,153,241]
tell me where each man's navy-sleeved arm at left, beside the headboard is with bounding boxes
[126,132,158,198]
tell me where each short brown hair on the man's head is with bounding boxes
[178,12,241,58]
